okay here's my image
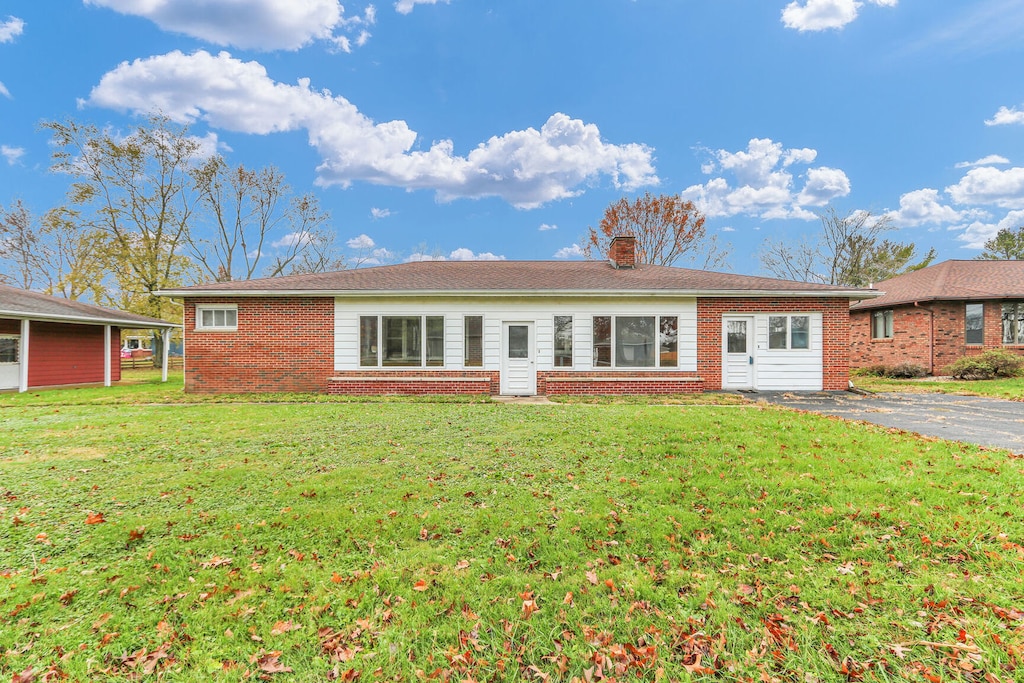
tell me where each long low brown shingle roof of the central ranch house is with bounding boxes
[161,261,871,299]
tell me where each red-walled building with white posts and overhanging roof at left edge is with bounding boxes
[0,285,179,391]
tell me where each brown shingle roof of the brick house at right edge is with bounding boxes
[851,261,1024,310]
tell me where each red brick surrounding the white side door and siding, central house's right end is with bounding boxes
[697,298,850,391]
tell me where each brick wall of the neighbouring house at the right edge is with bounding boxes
[850,301,1024,375]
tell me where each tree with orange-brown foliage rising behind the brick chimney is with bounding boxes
[583,193,730,270]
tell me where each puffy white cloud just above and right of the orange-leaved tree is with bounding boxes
[681,138,850,220]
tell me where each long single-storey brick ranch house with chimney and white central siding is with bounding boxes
[155,238,874,395]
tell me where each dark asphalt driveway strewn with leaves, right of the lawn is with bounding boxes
[751,391,1024,454]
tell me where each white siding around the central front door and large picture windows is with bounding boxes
[334,297,700,373]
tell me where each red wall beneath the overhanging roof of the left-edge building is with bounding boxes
[17,321,121,387]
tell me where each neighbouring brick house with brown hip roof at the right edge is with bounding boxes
[850,260,1024,375]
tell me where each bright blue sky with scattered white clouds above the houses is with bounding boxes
[0,0,1024,273]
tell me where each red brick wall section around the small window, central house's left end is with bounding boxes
[184,297,334,393]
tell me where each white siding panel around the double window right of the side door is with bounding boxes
[754,310,822,391]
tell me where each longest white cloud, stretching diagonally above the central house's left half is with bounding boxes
[82,50,658,209]
